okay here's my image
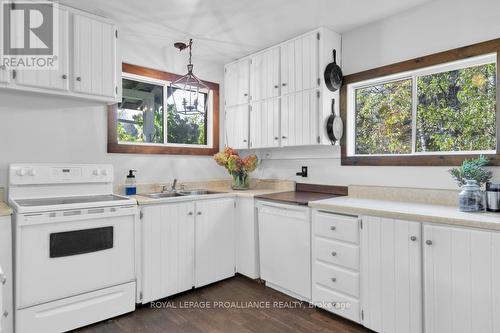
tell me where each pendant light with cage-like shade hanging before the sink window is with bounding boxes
[169,39,210,115]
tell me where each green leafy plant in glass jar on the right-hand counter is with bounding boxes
[450,155,493,211]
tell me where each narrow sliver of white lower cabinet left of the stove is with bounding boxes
[0,216,14,333]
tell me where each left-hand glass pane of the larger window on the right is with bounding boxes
[355,79,412,154]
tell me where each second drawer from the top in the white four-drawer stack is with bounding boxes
[313,237,359,270]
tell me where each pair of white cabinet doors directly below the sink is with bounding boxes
[139,198,235,303]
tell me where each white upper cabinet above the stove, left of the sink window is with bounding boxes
[0,6,120,103]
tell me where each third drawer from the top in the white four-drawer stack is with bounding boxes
[313,261,359,298]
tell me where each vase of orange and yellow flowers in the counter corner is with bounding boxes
[214,147,258,190]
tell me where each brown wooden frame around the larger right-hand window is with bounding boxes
[340,38,500,166]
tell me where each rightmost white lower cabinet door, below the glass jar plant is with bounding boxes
[424,225,500,333]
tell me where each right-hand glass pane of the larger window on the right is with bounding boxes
[416,64,496,152]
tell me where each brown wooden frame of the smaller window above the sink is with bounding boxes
[108,63,219,155]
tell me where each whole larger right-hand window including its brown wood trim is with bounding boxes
[341,40,500,165]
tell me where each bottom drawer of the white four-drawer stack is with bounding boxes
[312,284,360,323]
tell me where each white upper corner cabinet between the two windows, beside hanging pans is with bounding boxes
[224,28,341,149]
